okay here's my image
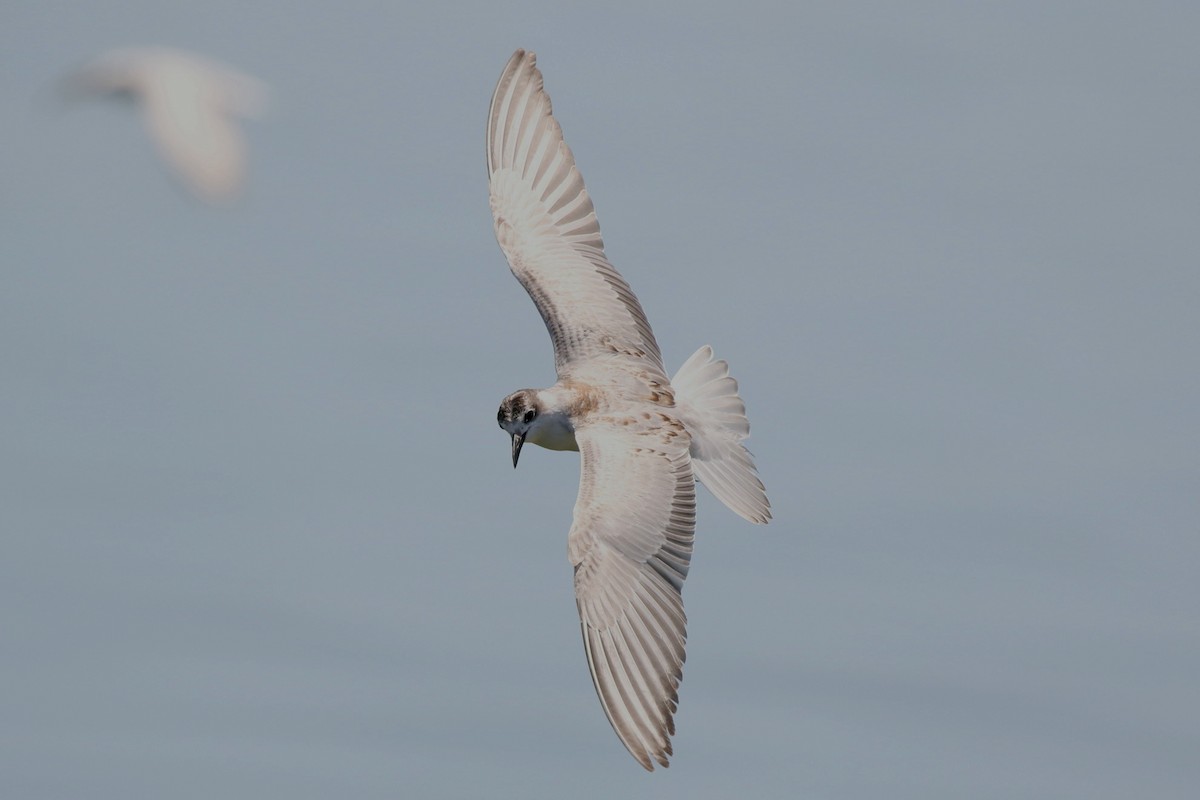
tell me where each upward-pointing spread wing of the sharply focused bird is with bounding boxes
[487,50,664,378]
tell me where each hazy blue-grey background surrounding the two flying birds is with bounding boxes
[0,0,1200,800]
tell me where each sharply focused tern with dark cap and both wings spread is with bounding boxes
[487,50,770,771]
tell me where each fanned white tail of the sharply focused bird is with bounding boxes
[671,344,770,524]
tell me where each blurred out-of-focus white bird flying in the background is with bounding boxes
[65,47,266,203]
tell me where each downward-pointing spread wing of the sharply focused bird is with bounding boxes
[568,421,696,770]
